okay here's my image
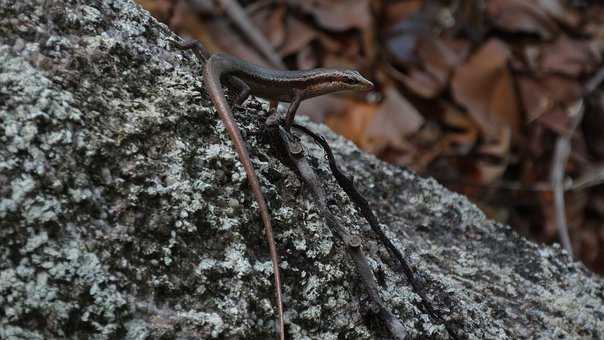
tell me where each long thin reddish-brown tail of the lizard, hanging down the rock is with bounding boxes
[204,57,285,340]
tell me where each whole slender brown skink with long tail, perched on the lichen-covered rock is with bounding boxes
[174,41,373,340]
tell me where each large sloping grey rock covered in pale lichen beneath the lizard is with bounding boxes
[0,0,604,339]
